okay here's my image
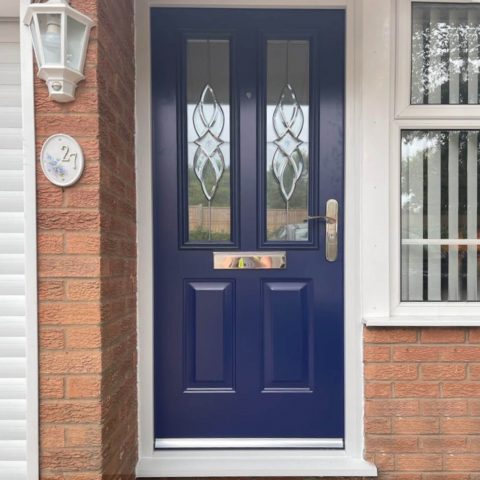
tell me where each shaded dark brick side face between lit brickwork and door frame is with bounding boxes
[97,0,137,479]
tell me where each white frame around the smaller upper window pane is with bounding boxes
[395,0,480,120]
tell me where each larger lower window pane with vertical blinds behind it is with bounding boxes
[401,130,480,301]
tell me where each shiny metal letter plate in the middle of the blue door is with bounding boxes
[213,252,287,270]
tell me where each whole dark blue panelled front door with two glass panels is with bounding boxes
[151,8,345,449]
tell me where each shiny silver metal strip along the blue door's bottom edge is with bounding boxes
[155,438,344,449]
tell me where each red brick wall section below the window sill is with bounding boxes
[364,328,480,480]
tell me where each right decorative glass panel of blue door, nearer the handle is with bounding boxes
[266,40,310,242]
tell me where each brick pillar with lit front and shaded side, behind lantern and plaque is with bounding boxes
[35,0,137,480]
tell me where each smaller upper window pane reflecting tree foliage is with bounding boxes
[411,2,480,105]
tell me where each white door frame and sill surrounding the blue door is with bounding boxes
[135,0,377,477]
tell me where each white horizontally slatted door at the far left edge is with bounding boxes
[0,20,27,480]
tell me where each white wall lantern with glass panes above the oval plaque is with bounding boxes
[24,0,93,102]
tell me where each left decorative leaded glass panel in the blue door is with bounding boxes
[187,39,231,243]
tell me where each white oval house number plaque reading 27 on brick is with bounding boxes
[40,133,84,187]
